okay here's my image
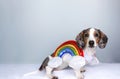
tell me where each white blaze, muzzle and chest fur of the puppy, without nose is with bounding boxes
[83,28,99,64]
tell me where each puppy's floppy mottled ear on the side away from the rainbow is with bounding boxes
[98,30,108,49]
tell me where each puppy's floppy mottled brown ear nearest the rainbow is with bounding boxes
[75,31,85,48]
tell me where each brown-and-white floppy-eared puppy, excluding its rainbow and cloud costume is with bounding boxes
[39,28,108,79]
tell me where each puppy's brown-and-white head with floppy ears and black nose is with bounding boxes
[76,28,108,49]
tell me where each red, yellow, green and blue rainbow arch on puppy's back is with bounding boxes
[52,40,84,58]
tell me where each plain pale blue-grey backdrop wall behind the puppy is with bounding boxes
[0,0,120,63]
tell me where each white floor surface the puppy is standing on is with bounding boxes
[0,63,120,79]
